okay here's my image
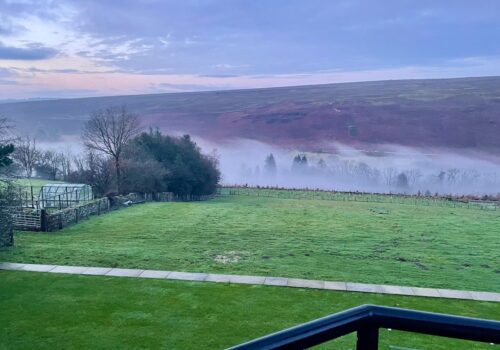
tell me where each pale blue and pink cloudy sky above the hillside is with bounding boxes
[0,0,500,100]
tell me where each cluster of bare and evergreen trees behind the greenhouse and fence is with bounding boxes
[0,107,220,195]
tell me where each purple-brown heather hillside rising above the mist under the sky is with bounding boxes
[0,77,500,153]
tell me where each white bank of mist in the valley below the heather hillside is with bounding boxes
[198,139,500,195]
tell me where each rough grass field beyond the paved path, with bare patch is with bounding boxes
[0,196,500,292]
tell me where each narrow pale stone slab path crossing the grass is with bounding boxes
[0,262,500,302]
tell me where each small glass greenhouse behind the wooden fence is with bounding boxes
[39,183,94,209]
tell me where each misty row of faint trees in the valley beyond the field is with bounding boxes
[238,153,499,195]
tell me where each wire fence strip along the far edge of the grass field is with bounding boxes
[217,186,500,210]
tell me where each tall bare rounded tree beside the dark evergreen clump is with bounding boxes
[82,107,142,193]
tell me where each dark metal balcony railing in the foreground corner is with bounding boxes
[231,305,500,350]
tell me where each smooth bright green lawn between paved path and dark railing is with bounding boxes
[0,271,500,350]
